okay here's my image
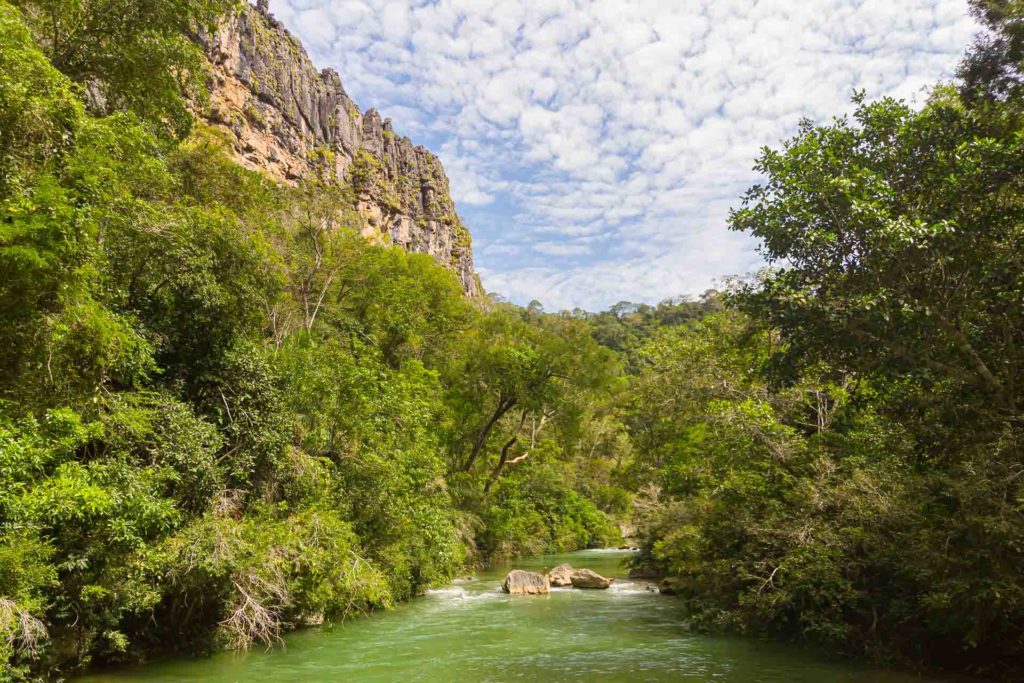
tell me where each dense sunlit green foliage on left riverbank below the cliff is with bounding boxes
[0,2,627,680]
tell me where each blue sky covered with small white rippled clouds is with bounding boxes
[270,0,977,310]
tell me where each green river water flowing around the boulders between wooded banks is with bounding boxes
[79,551,958,683]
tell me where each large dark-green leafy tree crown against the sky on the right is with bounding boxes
[732,91,1024,438]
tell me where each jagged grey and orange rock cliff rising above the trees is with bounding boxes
[200,2,482,296]
